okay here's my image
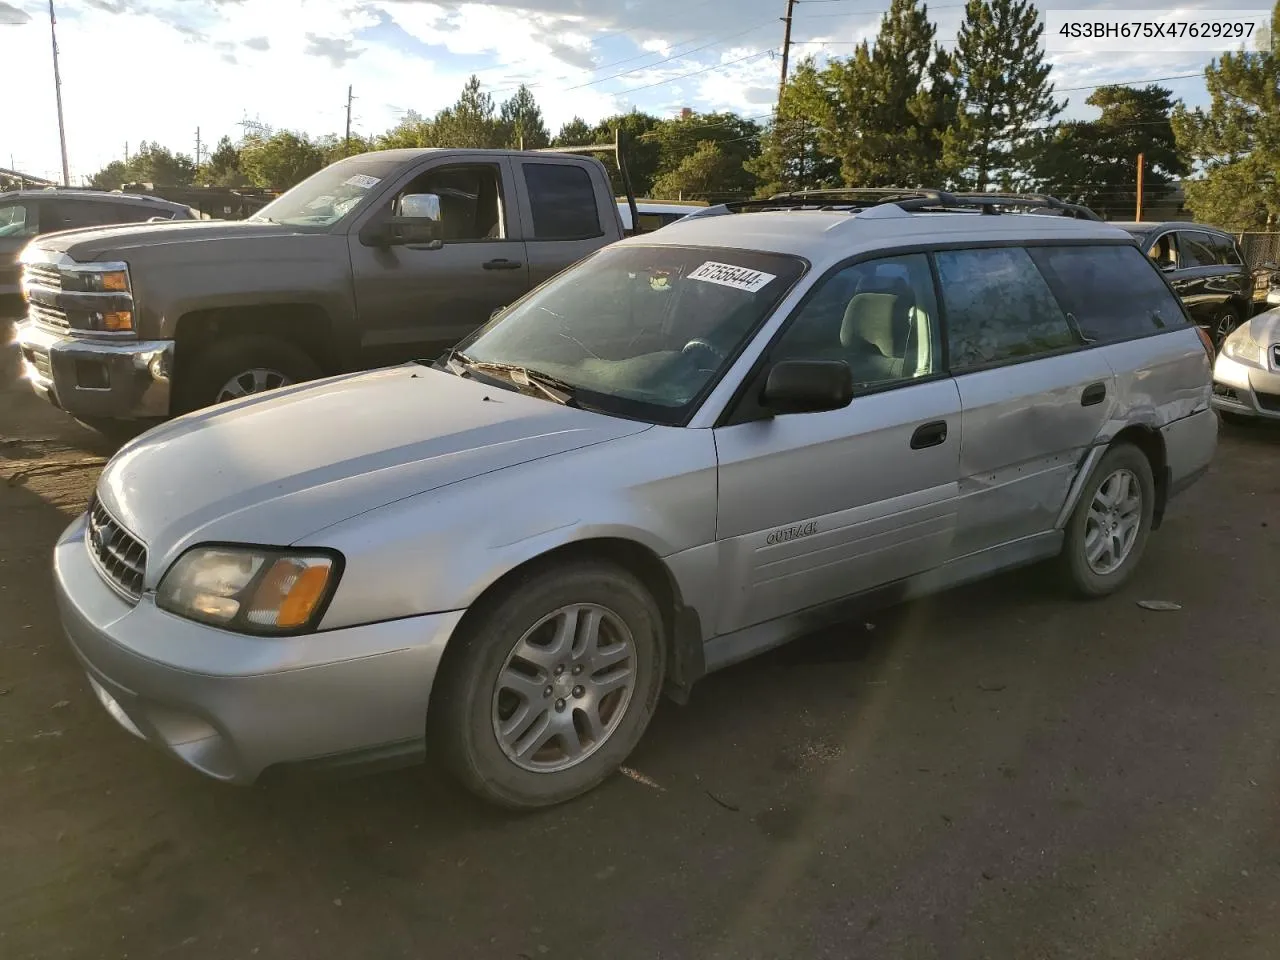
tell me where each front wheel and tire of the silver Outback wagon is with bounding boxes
[428,561,666,810]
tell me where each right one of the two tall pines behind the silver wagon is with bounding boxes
[945,0,1066,191]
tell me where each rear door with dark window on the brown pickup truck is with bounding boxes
[513,157,618,287]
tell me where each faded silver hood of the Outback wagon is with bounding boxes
[97,365,649,584]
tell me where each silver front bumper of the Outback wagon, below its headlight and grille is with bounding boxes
[54,517,462,783]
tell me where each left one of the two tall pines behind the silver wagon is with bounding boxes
[819,0,951,187]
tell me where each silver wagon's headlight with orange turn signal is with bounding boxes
[156,547,342,634]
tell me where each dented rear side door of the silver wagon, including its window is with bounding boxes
[934,247,1115,558]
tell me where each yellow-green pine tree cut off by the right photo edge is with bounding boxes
[1172,4,1280,229]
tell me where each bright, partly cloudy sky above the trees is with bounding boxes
[0,0,1263,183]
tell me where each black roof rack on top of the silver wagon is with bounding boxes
[680,187,1102,221]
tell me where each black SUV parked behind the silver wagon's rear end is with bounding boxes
[1114,223,1266,348]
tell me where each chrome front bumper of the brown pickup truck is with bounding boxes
[15,320,173,420]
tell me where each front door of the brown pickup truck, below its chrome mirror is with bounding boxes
[348,155,529,366]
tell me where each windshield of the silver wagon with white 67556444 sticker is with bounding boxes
[449,246,805,424]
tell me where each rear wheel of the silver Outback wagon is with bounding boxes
[1061,443,1156,596]
